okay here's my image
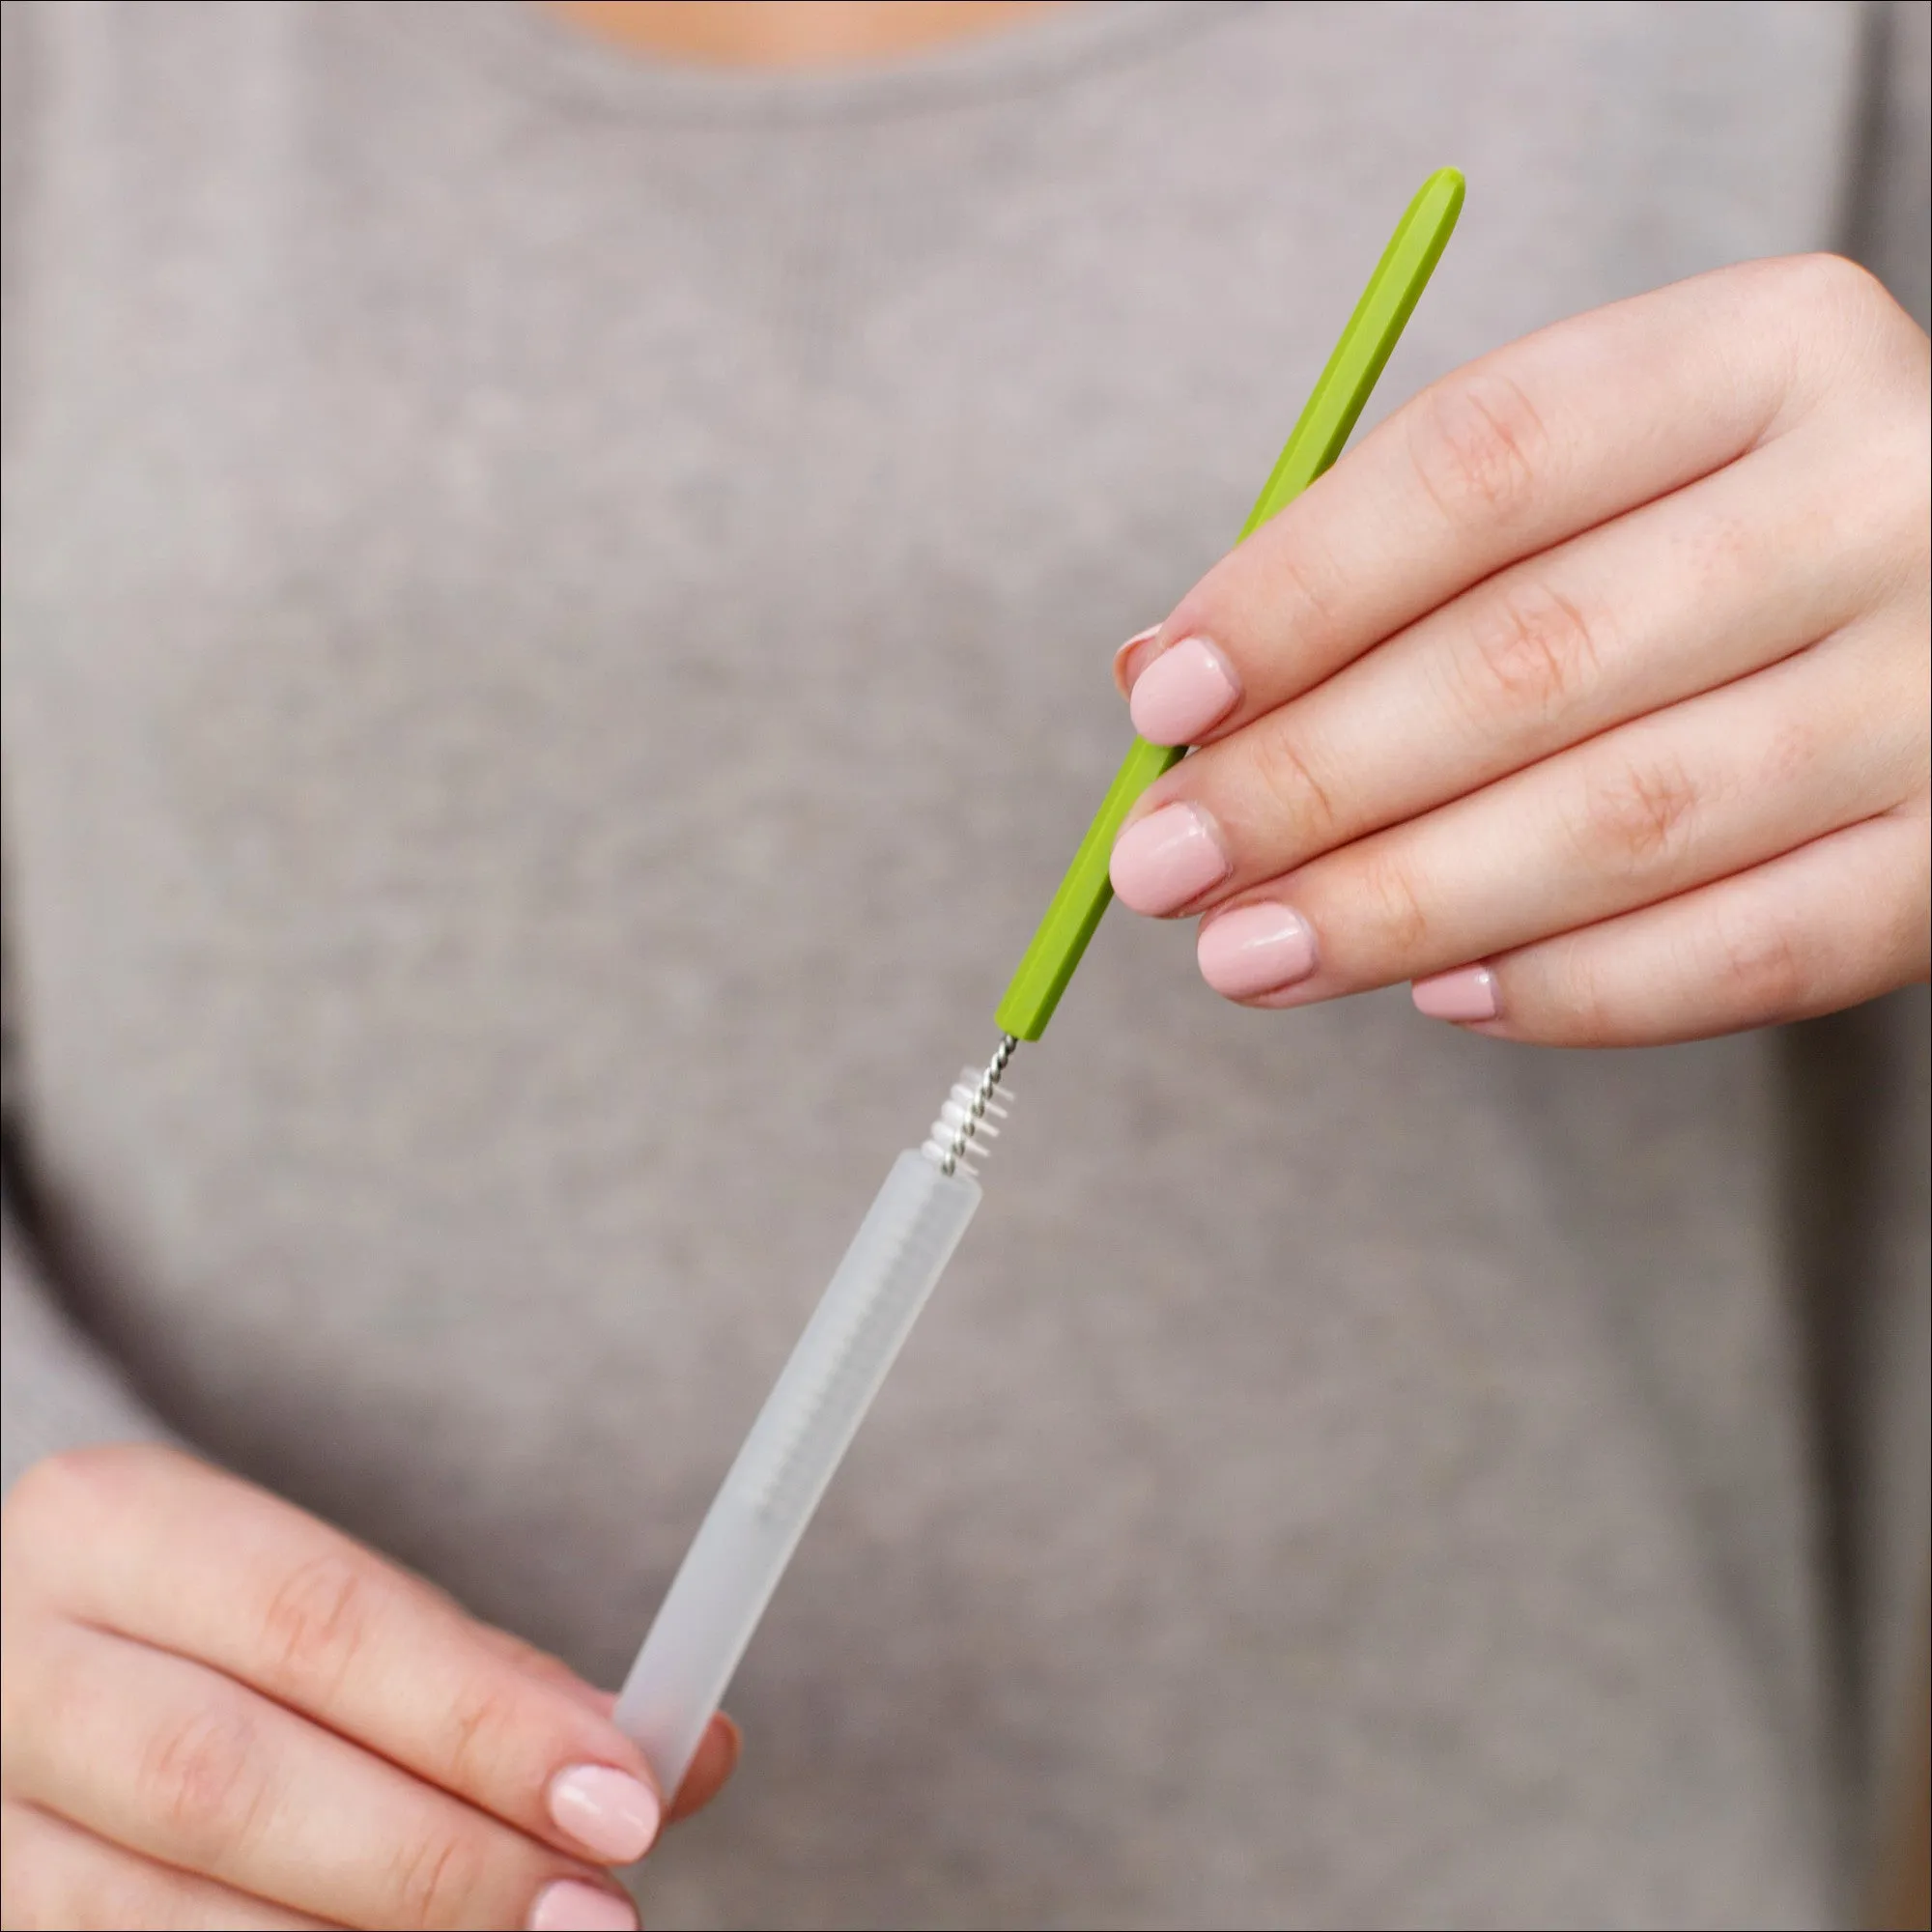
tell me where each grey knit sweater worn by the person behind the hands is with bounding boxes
[4,0,1926,1926]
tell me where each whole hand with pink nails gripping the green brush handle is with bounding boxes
[1113,257,1932,1047]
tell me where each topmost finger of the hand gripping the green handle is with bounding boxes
[1119,255,1876,744]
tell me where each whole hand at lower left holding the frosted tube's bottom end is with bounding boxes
[0,1445,738,1928]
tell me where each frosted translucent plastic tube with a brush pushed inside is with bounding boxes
[616,1144,985,1799]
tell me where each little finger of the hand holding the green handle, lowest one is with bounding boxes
[1414,800,1932,1047]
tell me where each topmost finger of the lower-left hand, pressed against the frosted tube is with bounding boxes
[26,1453,663,1864]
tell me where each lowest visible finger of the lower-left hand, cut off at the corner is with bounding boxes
[0,1799,328,1932]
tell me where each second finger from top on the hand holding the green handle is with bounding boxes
[1113,435,1891,916]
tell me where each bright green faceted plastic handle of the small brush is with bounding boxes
[997,168,1463,1039]
